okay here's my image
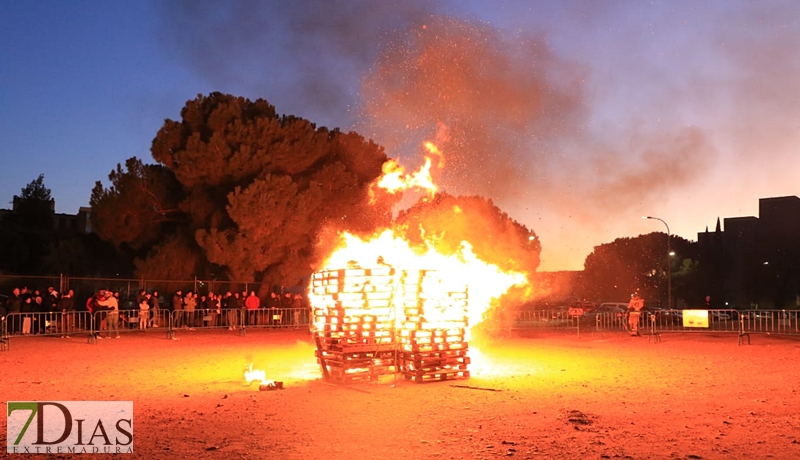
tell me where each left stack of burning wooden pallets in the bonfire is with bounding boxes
[312,267,397,383]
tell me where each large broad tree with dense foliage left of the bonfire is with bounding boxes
[92,93,391,285]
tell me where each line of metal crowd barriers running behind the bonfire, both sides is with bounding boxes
[6,308,800,351]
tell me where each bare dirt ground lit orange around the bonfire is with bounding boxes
[0,330,800,460]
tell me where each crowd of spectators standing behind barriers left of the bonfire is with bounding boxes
[0,286,308,338]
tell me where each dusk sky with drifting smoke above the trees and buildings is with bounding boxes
[0,0,800,270]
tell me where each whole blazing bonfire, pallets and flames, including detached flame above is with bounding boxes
[309,142,528,383]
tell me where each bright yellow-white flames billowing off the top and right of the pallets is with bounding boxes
[310,229,527,328]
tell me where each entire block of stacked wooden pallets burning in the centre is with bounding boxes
[312,267,469,382]
